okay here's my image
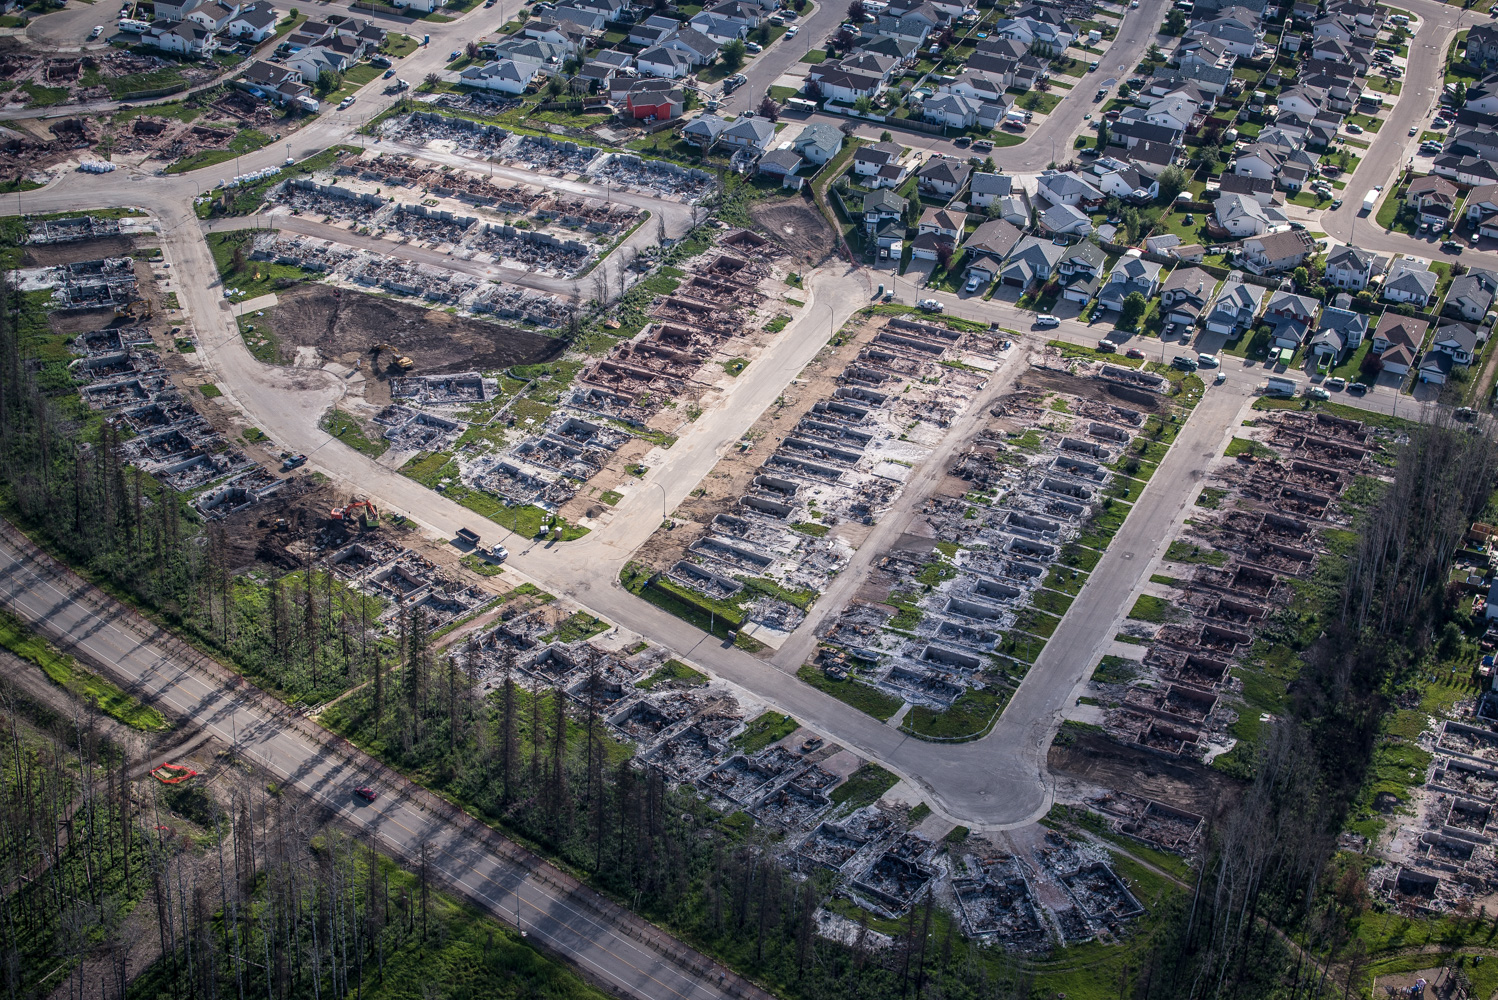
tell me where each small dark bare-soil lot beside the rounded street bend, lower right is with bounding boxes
[1047,734,1240,822]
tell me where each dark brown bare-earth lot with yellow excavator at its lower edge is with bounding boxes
[273,284,566,374]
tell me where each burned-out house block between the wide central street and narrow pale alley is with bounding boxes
[628,309,1002,645]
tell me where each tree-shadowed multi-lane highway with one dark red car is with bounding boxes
[0,536,754,1000]
